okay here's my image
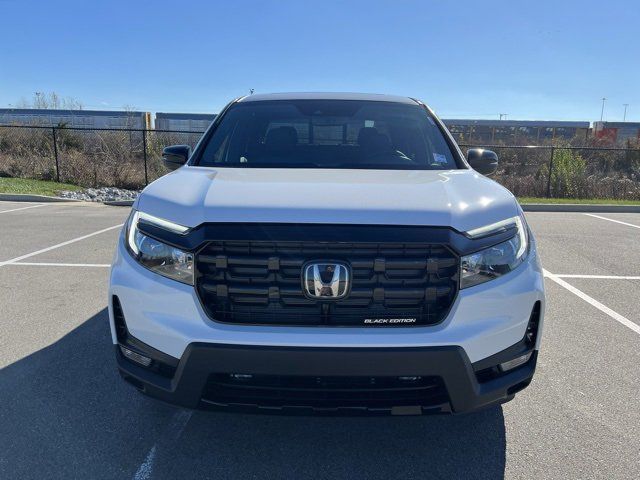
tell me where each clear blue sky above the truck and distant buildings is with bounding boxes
[0,0,640,121]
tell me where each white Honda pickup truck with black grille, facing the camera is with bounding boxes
[109,93,545,414]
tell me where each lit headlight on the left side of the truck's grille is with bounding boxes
[126,211,193,285]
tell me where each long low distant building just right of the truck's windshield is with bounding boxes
[442,119,589,144]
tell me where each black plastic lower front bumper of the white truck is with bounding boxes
[116,343,537,414]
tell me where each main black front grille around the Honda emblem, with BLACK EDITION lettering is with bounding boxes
[196,241,458,326]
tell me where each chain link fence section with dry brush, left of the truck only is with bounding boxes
[0,125,203,189]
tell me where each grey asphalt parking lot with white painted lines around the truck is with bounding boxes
[0,202,640,479]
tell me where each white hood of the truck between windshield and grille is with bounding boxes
[137,166,519,231]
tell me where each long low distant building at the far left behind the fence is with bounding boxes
[0,108,151,129]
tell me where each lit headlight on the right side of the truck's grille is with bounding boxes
[460,216,529,288]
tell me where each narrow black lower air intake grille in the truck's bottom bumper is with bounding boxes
[202,373,449,410]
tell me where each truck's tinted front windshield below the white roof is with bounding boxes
[196,100,458,170]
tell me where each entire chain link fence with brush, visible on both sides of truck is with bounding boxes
[0,125,640,200]
